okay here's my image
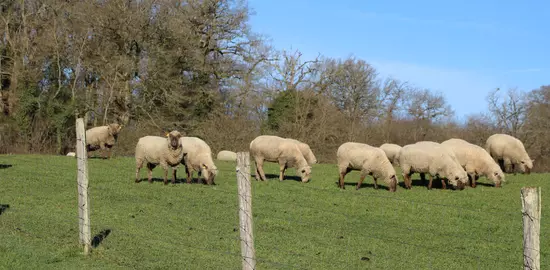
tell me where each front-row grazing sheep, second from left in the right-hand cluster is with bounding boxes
[398,143,468,190]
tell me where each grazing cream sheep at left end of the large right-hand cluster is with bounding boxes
[336,142,397,192]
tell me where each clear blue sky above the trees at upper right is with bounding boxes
[248,0,550,119]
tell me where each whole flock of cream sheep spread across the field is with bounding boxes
[82,124,533,192]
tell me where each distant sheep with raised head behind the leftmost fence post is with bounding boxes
[86,123,122,158]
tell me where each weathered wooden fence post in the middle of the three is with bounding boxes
[237,152,256,270]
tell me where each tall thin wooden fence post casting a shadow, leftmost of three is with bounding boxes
[76,118,92,255]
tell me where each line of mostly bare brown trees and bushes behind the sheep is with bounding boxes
[0,0,550,171]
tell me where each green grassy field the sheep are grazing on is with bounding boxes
[0,155,550,269]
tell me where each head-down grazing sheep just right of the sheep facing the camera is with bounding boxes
[180,137,218,185]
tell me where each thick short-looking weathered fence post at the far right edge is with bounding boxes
[521,187,542,270]
